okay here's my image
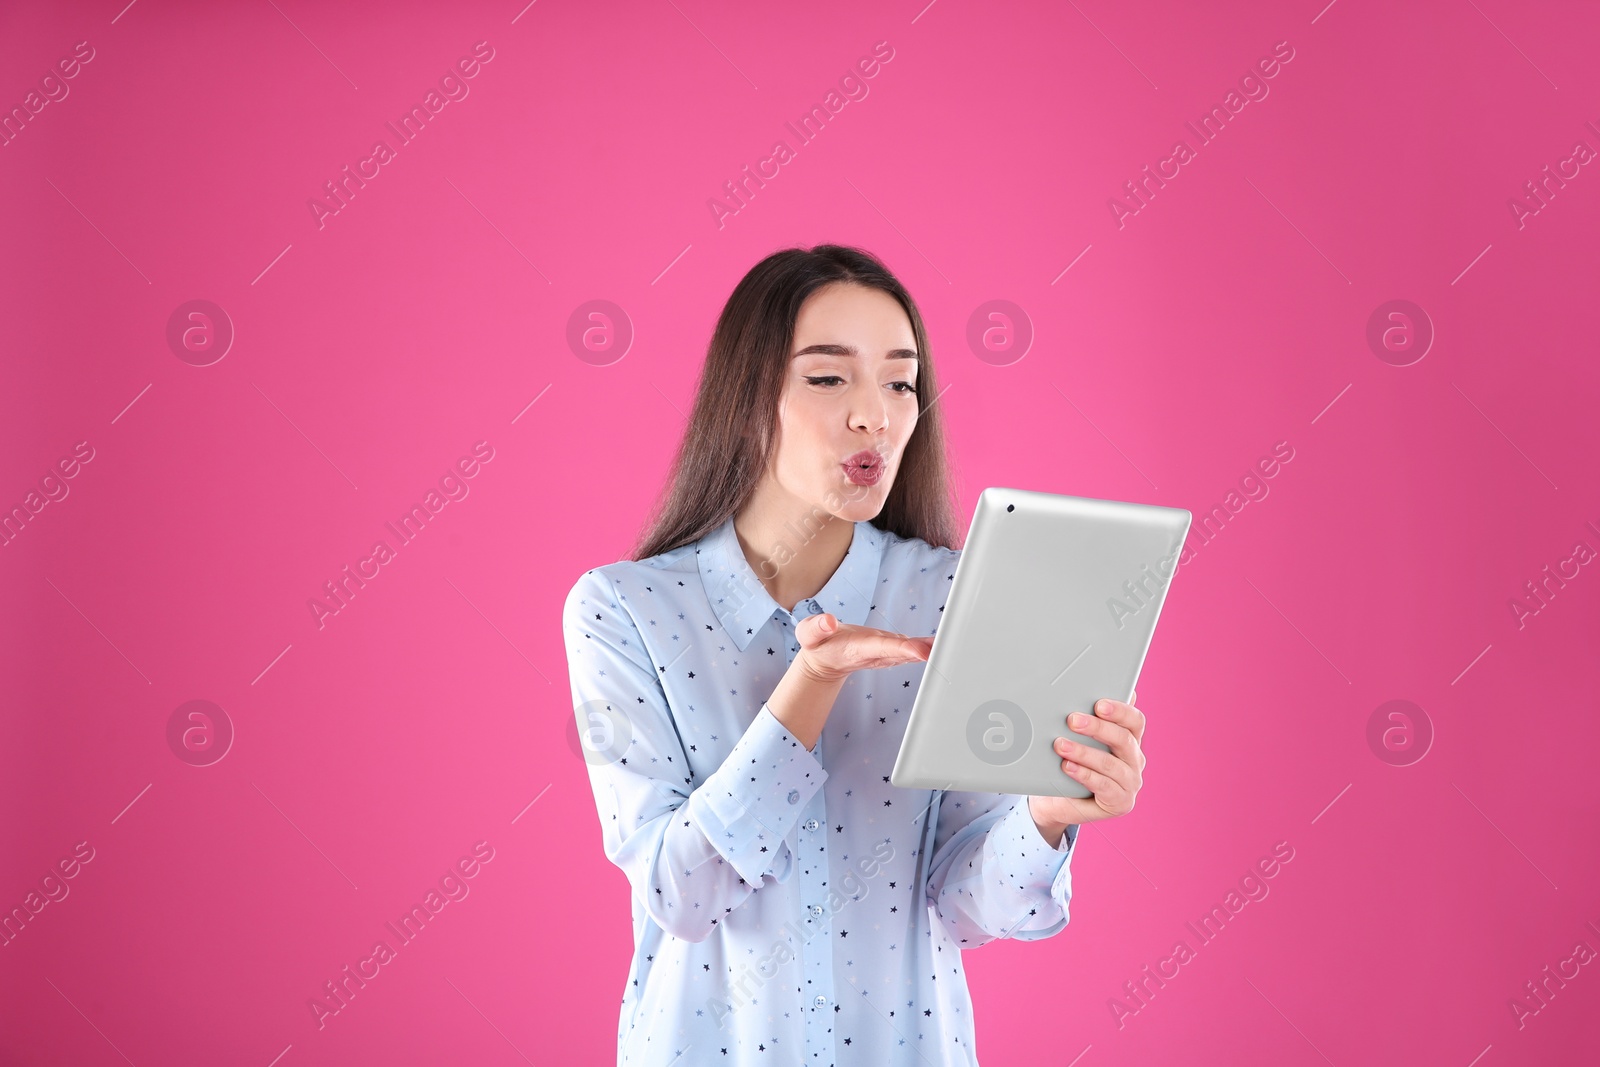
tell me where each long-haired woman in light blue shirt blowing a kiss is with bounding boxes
[563,245,1144,1067]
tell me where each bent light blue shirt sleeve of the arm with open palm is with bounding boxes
[562,569,827,941]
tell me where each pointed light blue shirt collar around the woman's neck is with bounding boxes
[696,515,885,653]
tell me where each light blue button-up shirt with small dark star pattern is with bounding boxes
[563,518,1078,1067]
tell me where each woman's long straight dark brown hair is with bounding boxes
[632,245,960,560]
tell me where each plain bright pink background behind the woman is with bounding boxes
[0,0,1600,1067]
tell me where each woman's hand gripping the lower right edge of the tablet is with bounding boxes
[1027,693,1144,840]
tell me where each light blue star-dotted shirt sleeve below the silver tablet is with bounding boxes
[926,792,1080,949]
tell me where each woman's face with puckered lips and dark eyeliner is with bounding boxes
[770,283,918,522]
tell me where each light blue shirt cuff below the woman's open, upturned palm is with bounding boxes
[685,704,825,886]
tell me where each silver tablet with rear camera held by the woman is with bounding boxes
[890,488,1190,797]
